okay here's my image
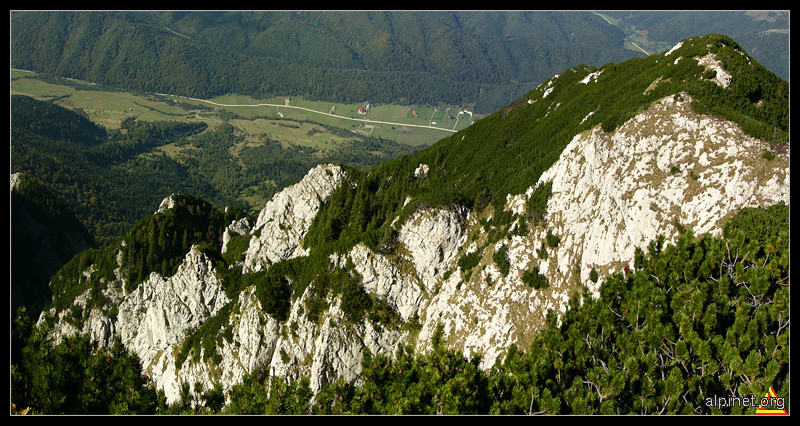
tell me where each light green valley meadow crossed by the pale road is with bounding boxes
[11,70,478,147]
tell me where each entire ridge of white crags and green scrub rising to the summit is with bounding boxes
[12,35,789,411]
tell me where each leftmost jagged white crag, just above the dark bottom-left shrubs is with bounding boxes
[39,246,236,402]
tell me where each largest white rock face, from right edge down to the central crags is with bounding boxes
[372,92,790,368]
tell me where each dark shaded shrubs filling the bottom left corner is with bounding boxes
[10,313,166,414]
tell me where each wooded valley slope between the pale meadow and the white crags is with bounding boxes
[11,95,418,245]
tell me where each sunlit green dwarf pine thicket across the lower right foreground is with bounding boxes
[314,201,789,414]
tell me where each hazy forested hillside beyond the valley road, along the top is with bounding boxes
[11,11,630,112]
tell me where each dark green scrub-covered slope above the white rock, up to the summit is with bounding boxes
[296,35,789,258]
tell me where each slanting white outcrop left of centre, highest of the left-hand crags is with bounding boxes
[244,164,345,272]
